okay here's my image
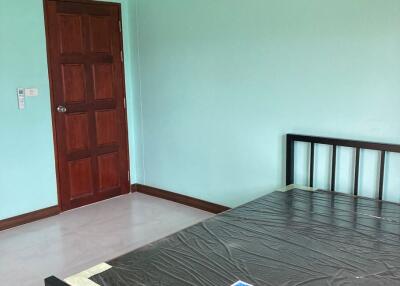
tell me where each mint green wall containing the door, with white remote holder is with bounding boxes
[0,0,136,219]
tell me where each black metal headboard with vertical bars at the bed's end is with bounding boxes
[286,134,400,200]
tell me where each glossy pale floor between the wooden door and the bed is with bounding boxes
[0,193,212,286]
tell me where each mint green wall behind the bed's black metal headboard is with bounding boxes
[138,0,400,206]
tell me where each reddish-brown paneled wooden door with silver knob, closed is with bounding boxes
[45,0,129,210]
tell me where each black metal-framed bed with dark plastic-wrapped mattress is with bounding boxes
[45,134,400,286]
